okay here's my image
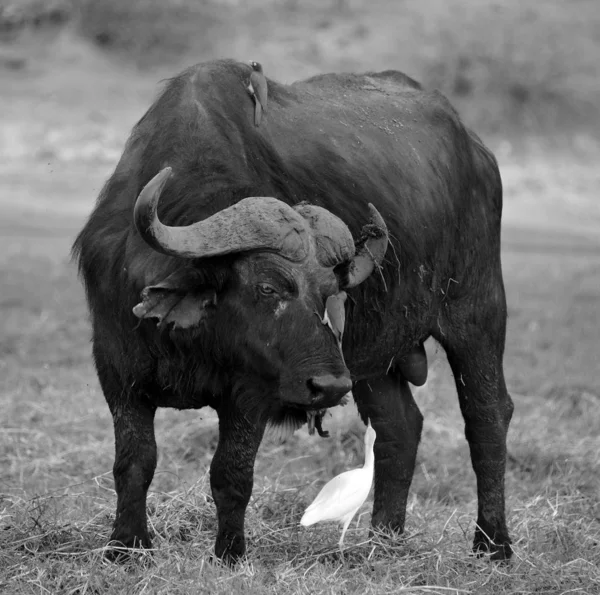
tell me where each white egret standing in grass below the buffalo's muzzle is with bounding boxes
[300,421,376,549]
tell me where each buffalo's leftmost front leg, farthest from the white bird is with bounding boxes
[94,350,157,548]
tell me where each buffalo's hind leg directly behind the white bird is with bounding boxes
[352,374,423,532]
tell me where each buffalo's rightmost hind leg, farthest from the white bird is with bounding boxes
[438,291,513,560]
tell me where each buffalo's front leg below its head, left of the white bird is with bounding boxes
[210,406,266,562]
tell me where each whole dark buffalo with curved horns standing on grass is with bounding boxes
[74,61,513,559]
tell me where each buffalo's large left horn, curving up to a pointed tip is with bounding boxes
[134,167,310,261]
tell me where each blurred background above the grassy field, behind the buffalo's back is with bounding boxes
[0,0,600,235]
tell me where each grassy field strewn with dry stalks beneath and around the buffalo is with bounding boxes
[0,211,600,594]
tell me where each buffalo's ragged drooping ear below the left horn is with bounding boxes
[133,274,217,329]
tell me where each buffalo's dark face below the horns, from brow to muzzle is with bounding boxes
[217,254,351,408]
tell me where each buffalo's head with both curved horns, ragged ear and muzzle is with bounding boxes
[134,168,388,410]
